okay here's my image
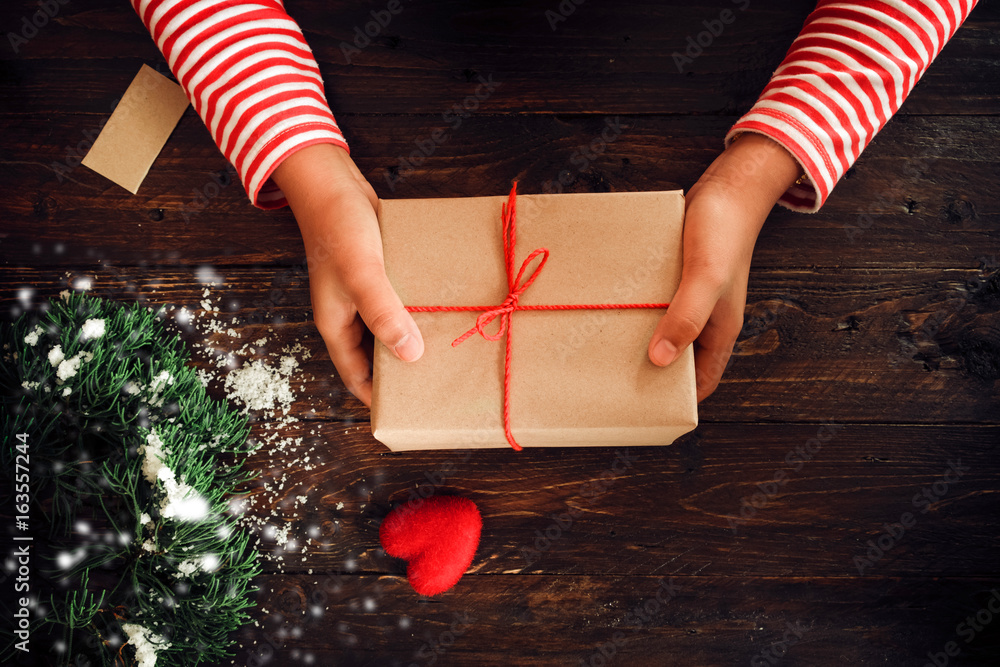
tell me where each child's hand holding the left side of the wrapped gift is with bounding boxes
[273,144,424,406]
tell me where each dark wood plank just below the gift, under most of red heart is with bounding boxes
[207,421,1000,585]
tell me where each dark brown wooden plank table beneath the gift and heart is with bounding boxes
[0,0,1000,666]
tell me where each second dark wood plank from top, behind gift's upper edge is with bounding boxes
[0,115,1000,268]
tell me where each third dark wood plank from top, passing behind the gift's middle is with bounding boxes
[0,264,1000,424]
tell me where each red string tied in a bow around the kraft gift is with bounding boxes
[406,181,670,451]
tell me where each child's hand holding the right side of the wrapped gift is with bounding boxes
[649,133,800,401]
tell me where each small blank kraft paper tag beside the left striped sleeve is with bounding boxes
[83,65,188,194]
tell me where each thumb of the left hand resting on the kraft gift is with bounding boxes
[350,266,424,361]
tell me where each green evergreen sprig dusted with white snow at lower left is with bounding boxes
[0,294,260,667]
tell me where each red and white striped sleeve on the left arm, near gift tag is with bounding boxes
[130,0,349,209]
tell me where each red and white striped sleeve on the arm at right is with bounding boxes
[726,0,977,213]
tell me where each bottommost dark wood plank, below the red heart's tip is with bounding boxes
[226,568,1000,667]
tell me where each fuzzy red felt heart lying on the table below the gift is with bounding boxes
[379,496,483,595]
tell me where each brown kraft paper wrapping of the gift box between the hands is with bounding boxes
[372,191,698,451]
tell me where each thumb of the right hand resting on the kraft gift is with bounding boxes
[648,279,718,366]
